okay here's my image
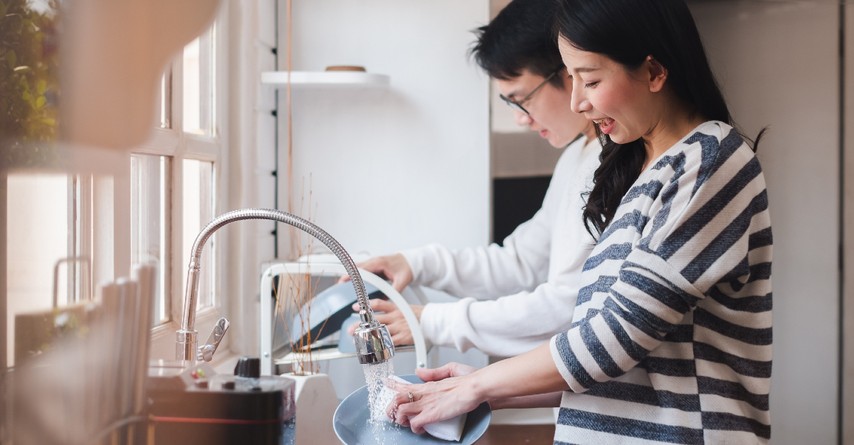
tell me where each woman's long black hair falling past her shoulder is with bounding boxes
[556,0,761,234]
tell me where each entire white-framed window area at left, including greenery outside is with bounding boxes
[0,0,228,368]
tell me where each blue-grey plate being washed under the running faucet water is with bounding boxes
[332,375,492,445]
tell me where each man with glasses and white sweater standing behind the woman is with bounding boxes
[352,0,601,357]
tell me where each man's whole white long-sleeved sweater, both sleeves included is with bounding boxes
[402,137,601,357]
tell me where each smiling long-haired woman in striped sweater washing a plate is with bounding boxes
[389,0,772,444]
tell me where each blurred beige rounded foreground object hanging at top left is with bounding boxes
[60,0,220,148]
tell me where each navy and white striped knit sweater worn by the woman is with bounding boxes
[551,122,772,444]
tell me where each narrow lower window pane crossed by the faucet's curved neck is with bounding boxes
[182,159,217,309]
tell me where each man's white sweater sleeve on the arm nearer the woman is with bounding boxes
[410,140,599,357]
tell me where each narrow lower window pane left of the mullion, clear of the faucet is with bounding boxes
[131,154,172,326]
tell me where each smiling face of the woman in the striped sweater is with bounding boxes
[558,38,658,144]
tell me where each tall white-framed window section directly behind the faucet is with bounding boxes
[135,15,225,359]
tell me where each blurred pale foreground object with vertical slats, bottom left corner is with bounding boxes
[9,265,157,445]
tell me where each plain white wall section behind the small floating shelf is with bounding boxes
[270,0,489,254]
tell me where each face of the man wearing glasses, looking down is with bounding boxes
[495,70,590,148]
